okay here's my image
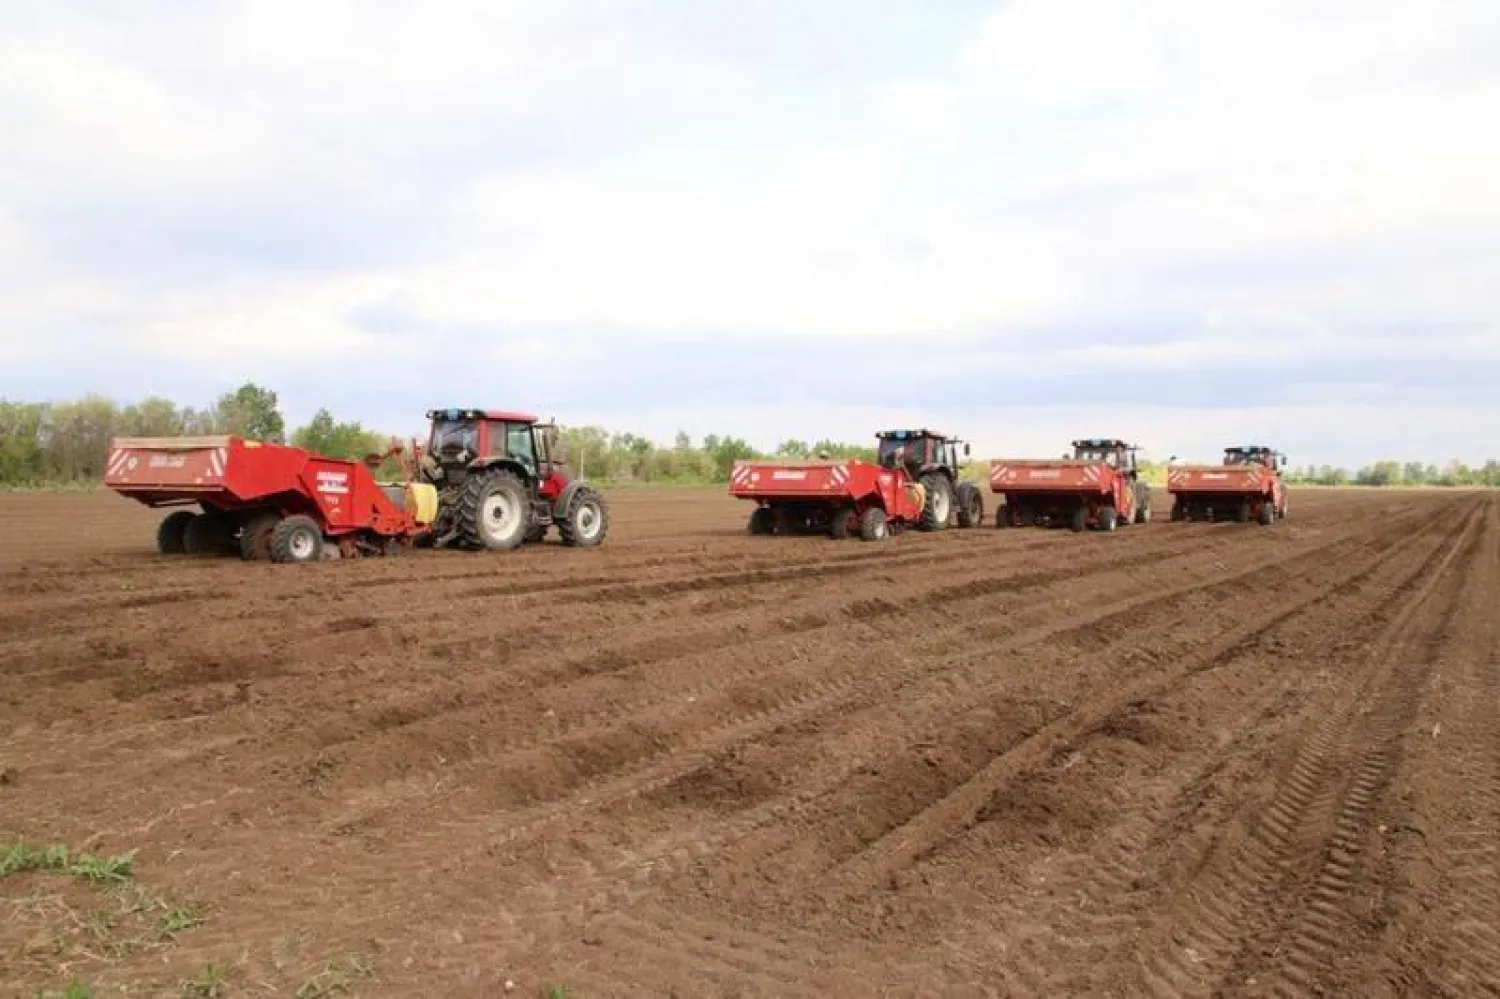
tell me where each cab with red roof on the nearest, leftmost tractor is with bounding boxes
[423,410,561,480]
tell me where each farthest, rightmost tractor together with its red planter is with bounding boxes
[1167,444,1287,527]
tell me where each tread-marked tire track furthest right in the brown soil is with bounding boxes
[1137,498,1479,998]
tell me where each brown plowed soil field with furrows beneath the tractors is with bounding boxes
[0,491,1500,998]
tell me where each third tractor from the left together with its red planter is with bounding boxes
[990,438,1151,531]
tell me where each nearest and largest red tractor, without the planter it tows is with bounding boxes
[417,410,609,549]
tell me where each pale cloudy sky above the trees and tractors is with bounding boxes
[0,0,1500,464]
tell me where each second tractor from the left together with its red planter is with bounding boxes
[729,431,984,542]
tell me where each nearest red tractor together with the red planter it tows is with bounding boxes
[105,410,609,563]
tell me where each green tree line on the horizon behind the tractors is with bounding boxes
[0,383,1500,489]
